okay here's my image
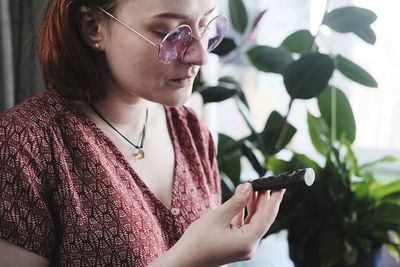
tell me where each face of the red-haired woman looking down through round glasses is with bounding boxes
[102,0,215,106]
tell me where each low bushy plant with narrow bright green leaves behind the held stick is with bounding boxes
[267,120,400,267]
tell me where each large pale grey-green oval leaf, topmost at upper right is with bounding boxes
[322,6,376,32]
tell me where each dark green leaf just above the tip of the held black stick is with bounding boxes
[261,111,297,155]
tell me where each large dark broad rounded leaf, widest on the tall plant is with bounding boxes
[283,53,334,99]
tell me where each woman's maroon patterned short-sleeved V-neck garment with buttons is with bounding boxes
[0,91,221,266]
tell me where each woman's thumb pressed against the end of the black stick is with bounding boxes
[220,183,253,223]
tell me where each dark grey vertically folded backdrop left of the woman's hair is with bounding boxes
[0,0,45,110]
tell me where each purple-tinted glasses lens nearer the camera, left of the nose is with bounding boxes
[158,25,191,64]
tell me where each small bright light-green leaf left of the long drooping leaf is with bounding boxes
[307,113,330,156]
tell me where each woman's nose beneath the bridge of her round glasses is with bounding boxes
[180,38,208,66]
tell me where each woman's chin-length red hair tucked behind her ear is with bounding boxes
[37,0,116,100]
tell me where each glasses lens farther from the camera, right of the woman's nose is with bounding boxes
[203,16,228,52]
